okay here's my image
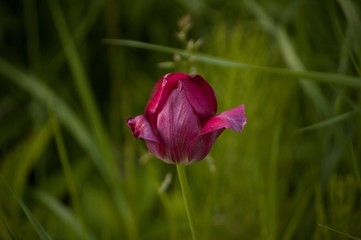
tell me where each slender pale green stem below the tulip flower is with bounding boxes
[177,164,196,240]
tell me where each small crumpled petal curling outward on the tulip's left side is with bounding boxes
[127,115,164,159]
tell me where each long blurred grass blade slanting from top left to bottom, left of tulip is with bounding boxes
[48,0,138,239]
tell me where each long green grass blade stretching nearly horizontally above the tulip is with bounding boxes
[103,39,361,88]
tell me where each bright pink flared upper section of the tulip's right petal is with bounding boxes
[199,104,247,135]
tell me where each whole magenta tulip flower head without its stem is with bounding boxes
[127,72,246,164]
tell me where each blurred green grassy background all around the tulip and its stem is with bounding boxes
[0,0,361,240]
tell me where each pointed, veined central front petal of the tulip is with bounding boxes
[157,83,200,163]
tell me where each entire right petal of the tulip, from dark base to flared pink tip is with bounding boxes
[189,105,247,163]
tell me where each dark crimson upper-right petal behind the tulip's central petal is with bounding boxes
[182,75,217,120]
